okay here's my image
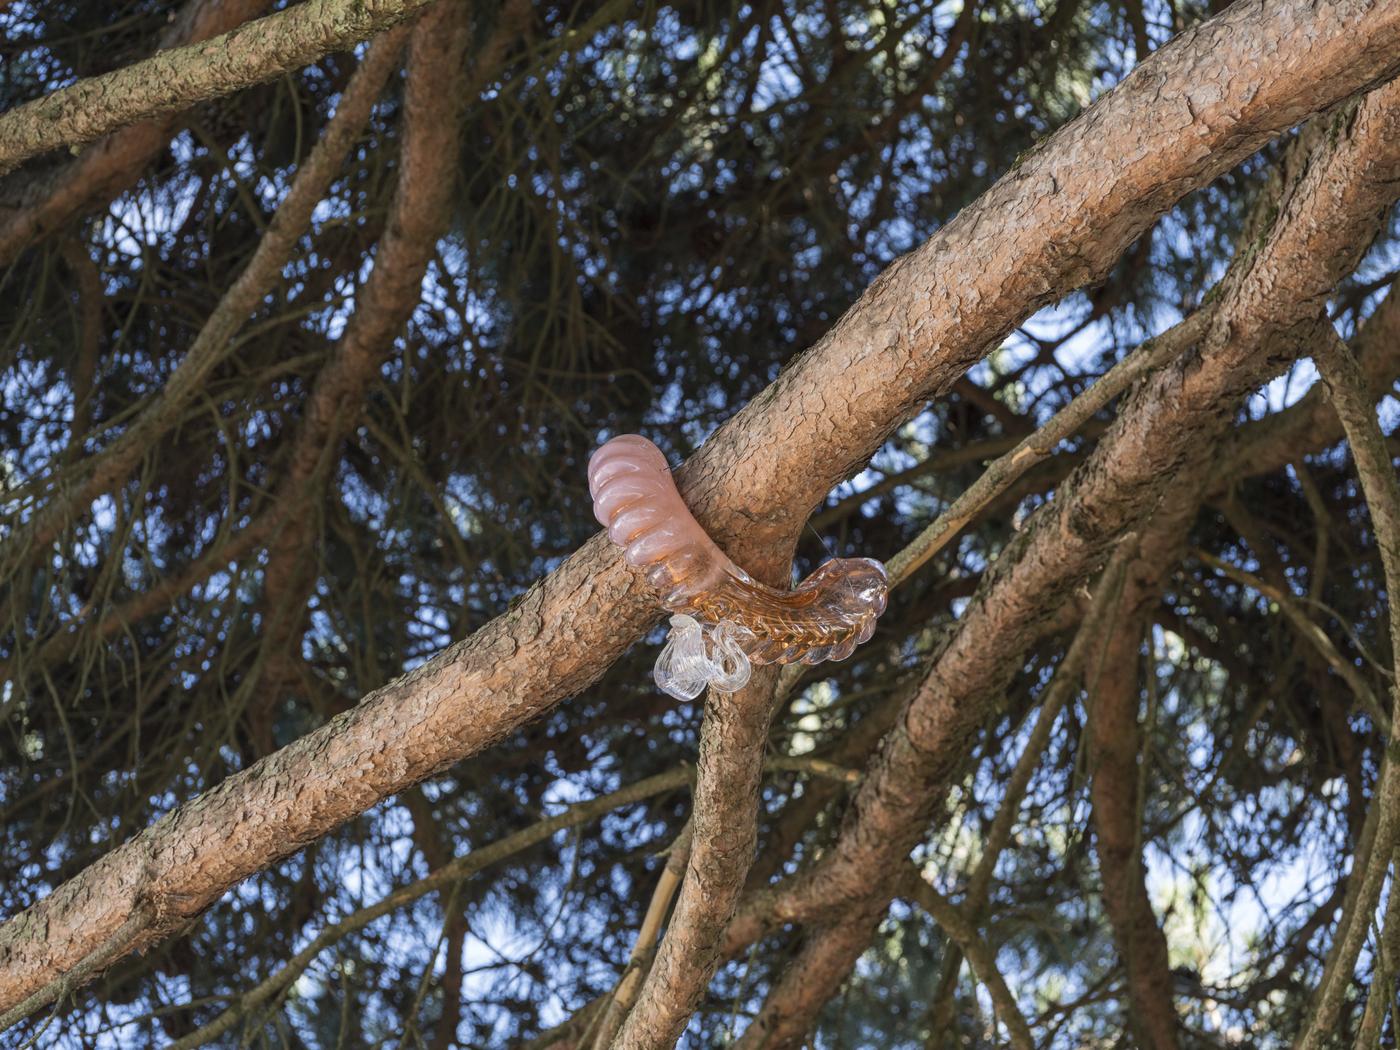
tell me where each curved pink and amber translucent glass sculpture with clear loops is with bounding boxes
[588,434,889,697]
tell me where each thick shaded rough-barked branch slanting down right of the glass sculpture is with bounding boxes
[731,78,1400,1046]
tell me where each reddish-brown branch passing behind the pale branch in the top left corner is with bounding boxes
[0,0,269,267]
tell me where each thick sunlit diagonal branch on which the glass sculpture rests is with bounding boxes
[0,0,1400,1005]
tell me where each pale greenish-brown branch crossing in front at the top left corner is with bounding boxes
[0,0,442,175]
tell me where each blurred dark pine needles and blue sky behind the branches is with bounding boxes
[0,0,1396,1049]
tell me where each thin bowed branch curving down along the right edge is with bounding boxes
[1295,337,1400,1050]
